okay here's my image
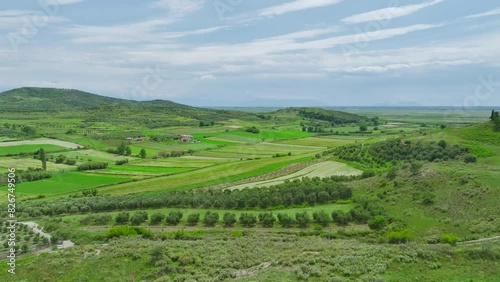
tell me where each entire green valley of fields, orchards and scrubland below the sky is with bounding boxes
[0,88,500,281]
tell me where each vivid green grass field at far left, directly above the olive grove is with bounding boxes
[16,172,132,196]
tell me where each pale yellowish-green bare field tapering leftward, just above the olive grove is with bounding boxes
[227,161,362,190]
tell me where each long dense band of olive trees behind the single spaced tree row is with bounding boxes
[18,178,352,216]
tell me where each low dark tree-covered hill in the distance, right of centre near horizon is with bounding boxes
[276,108,368,124]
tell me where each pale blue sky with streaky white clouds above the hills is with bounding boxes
[0,0,500,107]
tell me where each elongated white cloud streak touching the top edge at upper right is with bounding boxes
[342,0,444,24]
